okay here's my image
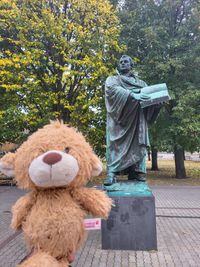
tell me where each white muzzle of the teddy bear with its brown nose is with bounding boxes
[29,150,79,188]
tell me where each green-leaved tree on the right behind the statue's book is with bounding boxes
[121,0,200,178]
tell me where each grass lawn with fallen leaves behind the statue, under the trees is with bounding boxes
[92,160,200,186]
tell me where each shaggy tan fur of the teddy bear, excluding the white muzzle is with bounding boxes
[2,122,111,267]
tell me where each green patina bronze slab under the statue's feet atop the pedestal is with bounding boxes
[104,181,152,197]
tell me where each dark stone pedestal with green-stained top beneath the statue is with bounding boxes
[101,182,157,250]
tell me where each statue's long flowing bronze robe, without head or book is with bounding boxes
[105,75,159,175]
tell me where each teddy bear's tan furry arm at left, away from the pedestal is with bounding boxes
[11,194,33,230]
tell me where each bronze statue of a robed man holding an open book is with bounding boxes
[104,55,169,185]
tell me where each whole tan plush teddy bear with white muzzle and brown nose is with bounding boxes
[0,121,112,267]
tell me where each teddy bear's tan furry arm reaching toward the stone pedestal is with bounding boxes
[74,188,112,218]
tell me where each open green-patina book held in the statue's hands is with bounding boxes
[139,83,170,108]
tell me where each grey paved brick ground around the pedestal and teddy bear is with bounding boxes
[0,186,200,267]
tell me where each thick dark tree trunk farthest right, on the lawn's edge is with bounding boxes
[174,146,187,179]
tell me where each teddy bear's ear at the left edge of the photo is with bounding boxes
[0,152,15,177]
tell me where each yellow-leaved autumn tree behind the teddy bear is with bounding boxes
[0,0,120,155]
